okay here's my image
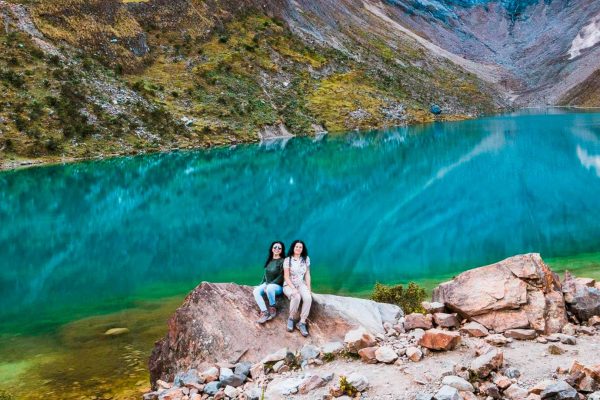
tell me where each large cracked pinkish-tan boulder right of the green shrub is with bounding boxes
[433,253,567,334]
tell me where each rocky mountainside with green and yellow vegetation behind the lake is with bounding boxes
[0,0,600,167]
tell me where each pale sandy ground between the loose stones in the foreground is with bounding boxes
[265,333,600,400]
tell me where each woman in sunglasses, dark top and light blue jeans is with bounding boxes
[254,241,285,324]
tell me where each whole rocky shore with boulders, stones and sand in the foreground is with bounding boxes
[144,254,600,400]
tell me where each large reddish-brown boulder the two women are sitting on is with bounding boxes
[149,282,403,387]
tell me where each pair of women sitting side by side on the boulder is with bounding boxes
[254,240,312,337]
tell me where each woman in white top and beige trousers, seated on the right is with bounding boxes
[283,240,312,337]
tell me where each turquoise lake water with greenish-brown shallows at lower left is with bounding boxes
[0,110,600,398]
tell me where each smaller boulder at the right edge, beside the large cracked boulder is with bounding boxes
[562,272,600,322]
